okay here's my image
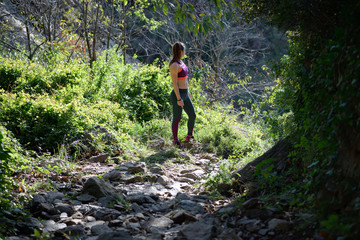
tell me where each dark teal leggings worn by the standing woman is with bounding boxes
[170,89,196,140]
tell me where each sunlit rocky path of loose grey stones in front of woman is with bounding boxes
[2,144,310,240]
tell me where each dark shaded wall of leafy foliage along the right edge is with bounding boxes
[238,0,360,236]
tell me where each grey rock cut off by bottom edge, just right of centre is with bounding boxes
[179,222,216,240]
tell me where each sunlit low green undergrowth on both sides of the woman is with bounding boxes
[0,45,269,232]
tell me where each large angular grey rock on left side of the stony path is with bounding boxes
[82,177,120,198]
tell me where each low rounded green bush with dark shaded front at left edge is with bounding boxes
[0,92,87,152]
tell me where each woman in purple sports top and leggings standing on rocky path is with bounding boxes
[169,42,196,148]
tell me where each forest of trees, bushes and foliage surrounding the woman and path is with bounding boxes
[0,0,360,238]
